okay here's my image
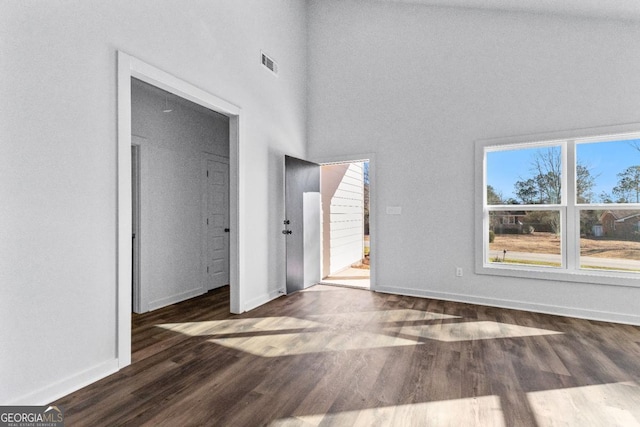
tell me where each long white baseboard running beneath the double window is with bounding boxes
[375,286,640,326]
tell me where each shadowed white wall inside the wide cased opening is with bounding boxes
[131,80,229,312]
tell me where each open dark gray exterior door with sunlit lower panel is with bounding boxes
[283,156,321,294]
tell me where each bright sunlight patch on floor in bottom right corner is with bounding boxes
[527,382,640,427]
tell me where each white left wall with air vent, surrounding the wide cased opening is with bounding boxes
[0,0,306,404]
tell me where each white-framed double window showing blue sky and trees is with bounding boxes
[476,126,640,286]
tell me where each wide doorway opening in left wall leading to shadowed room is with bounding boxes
[131,78,230,313]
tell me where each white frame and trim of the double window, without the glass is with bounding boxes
[474,123,640,287]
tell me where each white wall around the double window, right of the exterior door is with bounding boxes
[308,0,640,324]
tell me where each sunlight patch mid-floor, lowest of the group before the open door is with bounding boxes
[209,331,420,357]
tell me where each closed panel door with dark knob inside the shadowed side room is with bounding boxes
[205,156,229,290]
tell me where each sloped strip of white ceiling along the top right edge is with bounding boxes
[384,0,640,21]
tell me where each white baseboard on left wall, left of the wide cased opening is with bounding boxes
[5,359,118,406]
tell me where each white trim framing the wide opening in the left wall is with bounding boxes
[116,51,244,369]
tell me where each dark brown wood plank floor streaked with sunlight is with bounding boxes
[54,285,640,427]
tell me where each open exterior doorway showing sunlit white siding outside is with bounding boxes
[320,160,371,289]
